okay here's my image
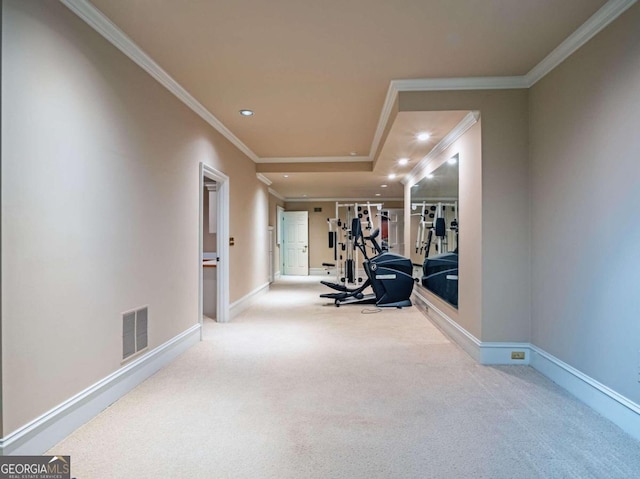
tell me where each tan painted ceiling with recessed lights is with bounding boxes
[82,0,606,197]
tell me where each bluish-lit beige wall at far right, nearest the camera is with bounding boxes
[530,4,640,403]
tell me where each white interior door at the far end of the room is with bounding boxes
[283,211,309,276]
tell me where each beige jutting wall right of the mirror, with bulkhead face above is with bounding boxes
[399,90,531,341]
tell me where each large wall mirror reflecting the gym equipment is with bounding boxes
[410,155,459,308]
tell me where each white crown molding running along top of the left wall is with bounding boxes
[60,0,258,161]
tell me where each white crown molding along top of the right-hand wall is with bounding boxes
[524,0,637,87]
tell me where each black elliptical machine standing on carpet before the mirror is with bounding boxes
[320,218,414,308]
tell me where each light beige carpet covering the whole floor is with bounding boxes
[49,278,640,479]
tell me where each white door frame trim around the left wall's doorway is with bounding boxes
[198,162,229,328]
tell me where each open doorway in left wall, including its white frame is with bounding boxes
[198,163,229,328]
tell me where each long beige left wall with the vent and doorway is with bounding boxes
[2,0,268,435]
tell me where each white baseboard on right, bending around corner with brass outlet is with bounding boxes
[414,291,640,441]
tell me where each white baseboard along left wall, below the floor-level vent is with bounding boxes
[0,324,200,455]
